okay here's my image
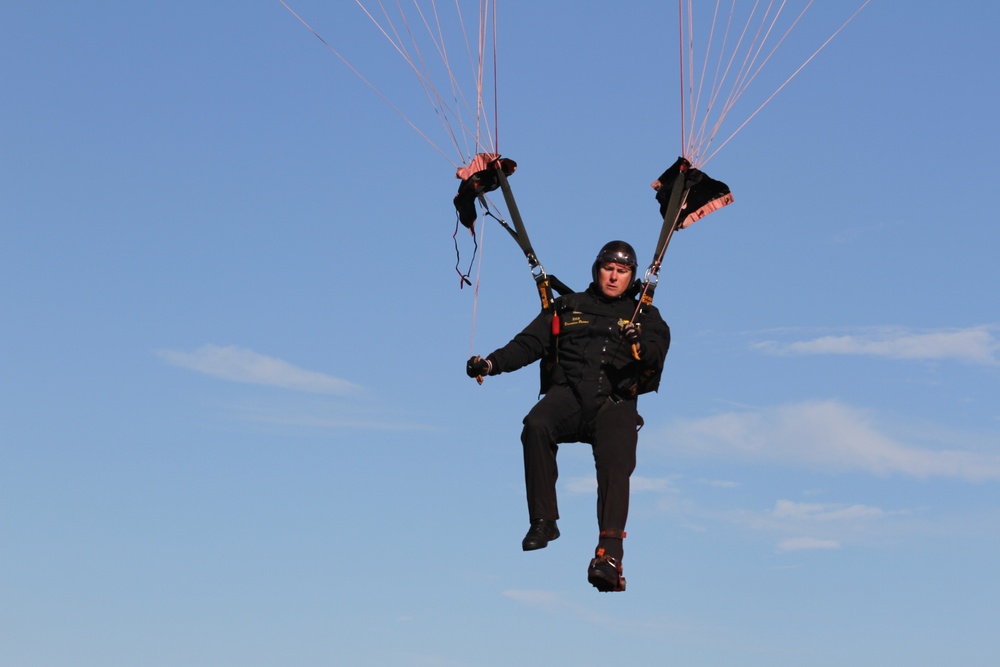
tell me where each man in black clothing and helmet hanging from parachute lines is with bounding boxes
[466,241,670,591]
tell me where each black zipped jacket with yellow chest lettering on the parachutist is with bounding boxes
[487,283,670,403]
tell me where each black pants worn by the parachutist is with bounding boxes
[521,386,639,558]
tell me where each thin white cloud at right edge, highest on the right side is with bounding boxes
[752,325,1000,366]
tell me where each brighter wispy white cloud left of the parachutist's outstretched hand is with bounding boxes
[157,345,361,396]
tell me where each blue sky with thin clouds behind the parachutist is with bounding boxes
[0,0,1000,667]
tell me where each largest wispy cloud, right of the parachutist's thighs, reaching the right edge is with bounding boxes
[648,401,1000,481]
